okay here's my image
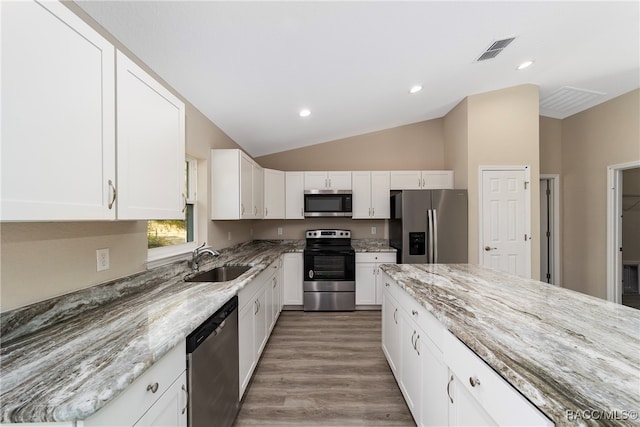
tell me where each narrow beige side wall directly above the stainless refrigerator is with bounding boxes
[443,98,469,189]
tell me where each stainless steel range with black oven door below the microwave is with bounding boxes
[303,230,356,311]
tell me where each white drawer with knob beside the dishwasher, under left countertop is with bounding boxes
[83,341,186,427]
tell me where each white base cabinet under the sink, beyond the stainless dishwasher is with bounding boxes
[238,259,280,399]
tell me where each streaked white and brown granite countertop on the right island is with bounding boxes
[381,264,640,425]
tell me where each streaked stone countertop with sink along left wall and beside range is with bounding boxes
[0,239,394,423]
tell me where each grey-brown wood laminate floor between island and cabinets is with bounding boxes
[235,311,415,427]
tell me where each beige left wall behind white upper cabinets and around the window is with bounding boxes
[0,2,251,311]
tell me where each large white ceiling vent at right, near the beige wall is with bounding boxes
[540,86,606,119]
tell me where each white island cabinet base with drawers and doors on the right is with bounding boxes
[380,272,553,426]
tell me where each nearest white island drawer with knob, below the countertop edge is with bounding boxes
[444,332,553,426]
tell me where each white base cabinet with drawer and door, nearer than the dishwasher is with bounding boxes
[77,342,188,427]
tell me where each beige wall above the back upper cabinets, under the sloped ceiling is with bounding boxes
[256,119,444,171]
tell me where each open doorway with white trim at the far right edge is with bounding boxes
[607,161,640,309]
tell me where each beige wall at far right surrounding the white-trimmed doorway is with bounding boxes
[561,90,640,298]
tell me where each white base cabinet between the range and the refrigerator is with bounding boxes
[356,252,396,305]
